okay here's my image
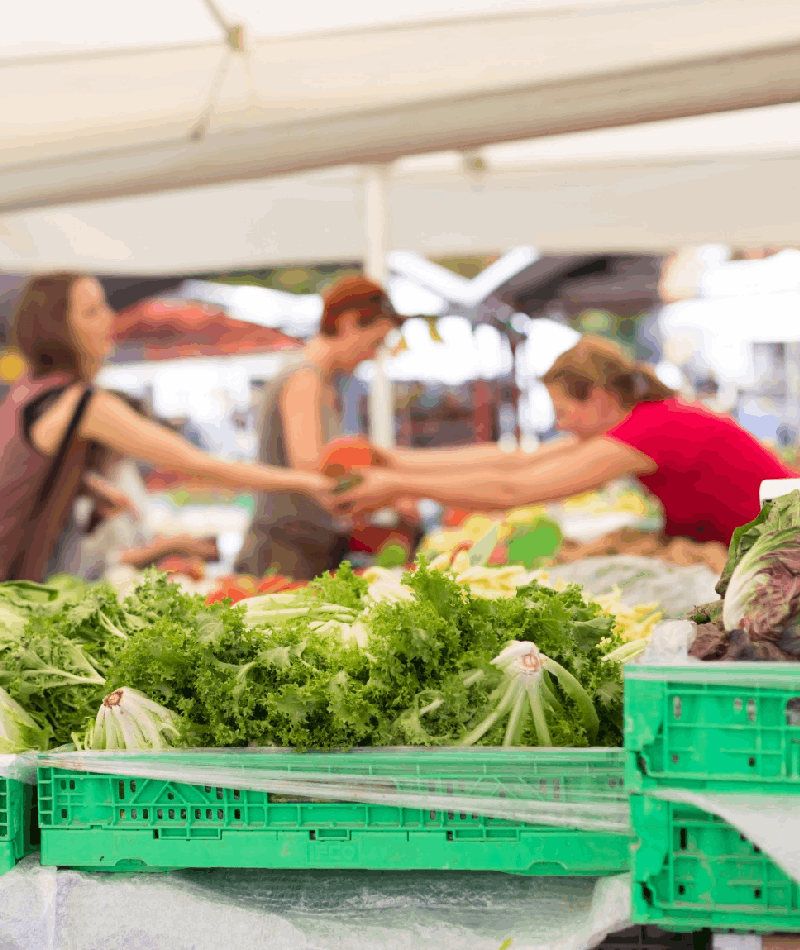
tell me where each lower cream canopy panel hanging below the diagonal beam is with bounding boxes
[0,104,800,275]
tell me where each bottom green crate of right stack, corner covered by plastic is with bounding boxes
[631,795,800,933]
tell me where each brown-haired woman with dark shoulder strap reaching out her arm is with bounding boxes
[0,274,329,581]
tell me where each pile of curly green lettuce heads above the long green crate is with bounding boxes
[0,561,622,750]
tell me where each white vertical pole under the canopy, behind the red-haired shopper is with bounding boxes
[364,165,395,449]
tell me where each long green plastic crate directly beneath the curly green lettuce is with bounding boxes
[39,749,630,876]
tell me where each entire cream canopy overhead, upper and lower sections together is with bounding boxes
[0,0,800,273]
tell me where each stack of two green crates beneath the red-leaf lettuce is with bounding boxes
[625,663,800,933]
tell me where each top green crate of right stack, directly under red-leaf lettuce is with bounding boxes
[625,663,800,795]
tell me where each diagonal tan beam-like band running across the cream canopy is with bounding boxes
[0,44,800,214]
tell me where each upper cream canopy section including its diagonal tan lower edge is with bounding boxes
[6,0,800,211]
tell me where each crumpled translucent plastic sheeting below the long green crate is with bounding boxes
[0,855,630,950]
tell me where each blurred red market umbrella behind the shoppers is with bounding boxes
[115,299,302,360]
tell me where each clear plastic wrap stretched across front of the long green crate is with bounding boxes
[39,748,630,832]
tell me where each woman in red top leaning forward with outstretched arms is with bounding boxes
[347,336,797,544]
